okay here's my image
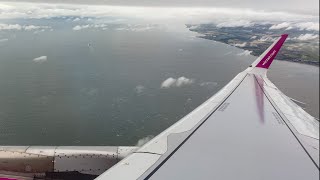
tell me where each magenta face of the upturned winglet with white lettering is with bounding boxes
[256,34,288,69]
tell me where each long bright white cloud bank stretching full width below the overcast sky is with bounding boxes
[0,2,318,27]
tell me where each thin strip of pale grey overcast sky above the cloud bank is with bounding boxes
[5,0,319,15]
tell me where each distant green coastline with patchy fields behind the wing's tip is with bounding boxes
[186,23,319,66]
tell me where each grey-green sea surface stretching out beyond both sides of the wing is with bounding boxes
[0,20,319,145]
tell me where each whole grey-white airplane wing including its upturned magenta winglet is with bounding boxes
[97,34,319,180]
